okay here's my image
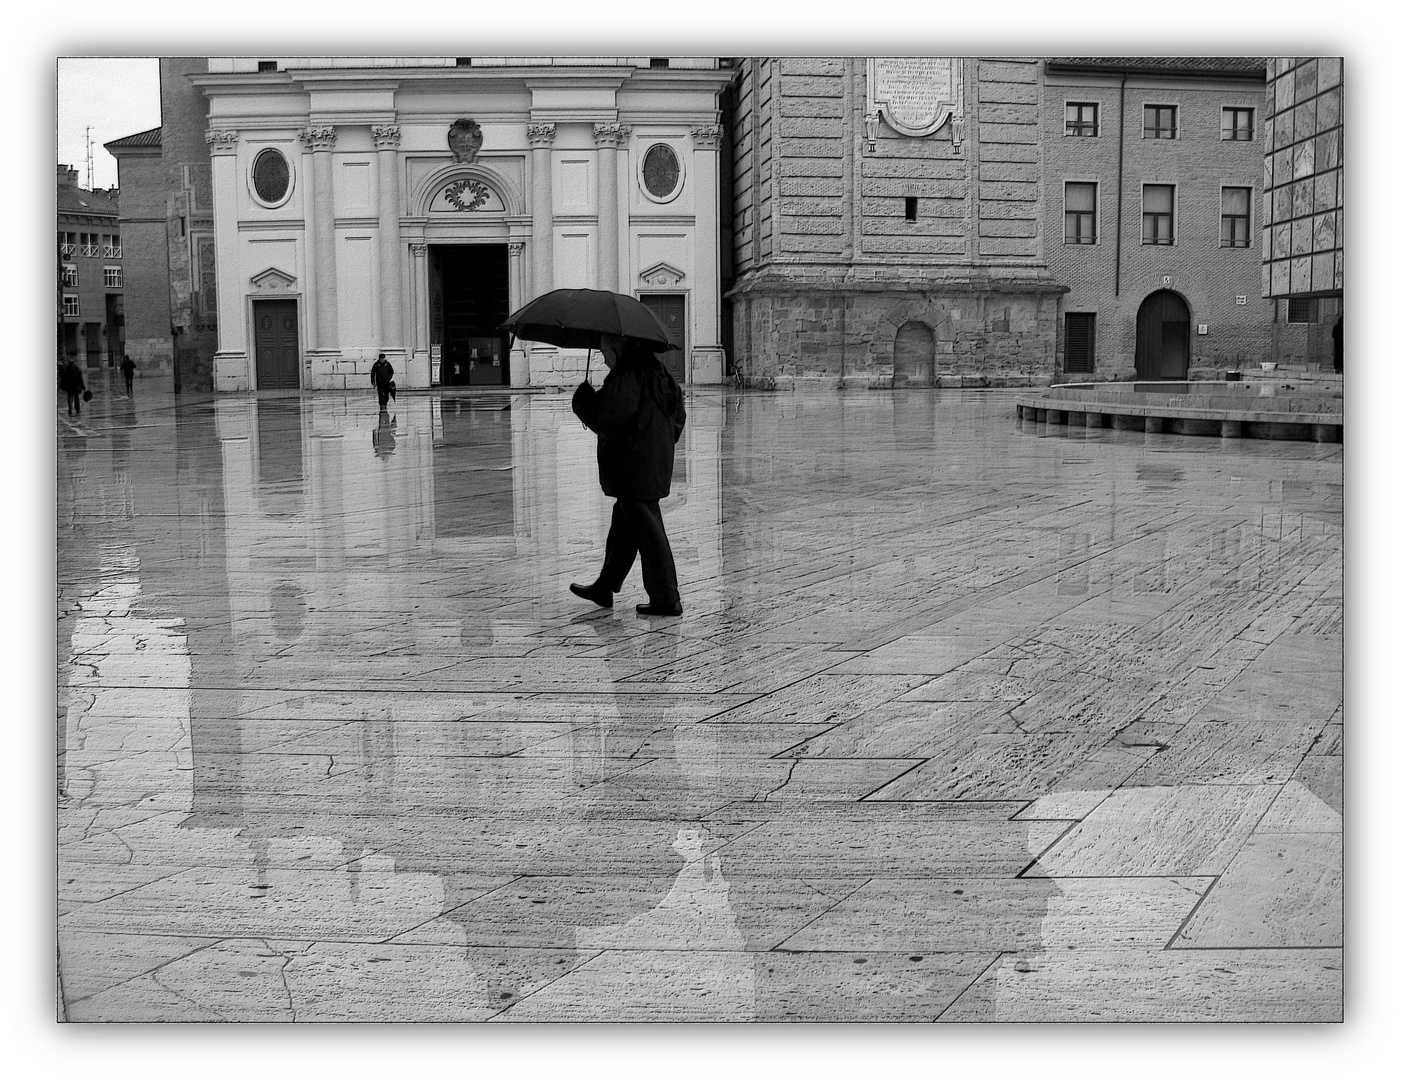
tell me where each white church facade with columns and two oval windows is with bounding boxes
[184,57,730,389]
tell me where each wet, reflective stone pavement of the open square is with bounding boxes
[57,384,1344,1023]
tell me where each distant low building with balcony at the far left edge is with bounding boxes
[55,165,123,370]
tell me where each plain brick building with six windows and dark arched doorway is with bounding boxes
[1040,57,1272,380]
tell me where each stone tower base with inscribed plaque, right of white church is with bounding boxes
[726,57,1065,387]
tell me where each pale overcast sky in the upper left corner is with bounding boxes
[57,56,161,188]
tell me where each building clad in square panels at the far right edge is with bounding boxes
[1261,56,1344,367]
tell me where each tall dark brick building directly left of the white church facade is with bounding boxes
[104,56,219,391]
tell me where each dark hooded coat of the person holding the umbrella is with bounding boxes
[573,349,686,500]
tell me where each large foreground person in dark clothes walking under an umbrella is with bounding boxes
[569,335,686,615]
